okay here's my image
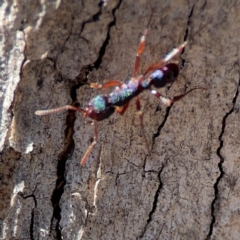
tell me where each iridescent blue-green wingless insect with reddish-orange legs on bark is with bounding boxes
[35,14,205,165]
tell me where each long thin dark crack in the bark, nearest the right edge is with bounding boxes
[206,74,240,240]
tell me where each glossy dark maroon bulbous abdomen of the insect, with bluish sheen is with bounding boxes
[150,63,179,88]
